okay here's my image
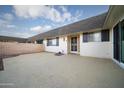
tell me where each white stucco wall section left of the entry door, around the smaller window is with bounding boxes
[43,36,67,54]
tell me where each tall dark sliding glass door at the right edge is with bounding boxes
[113,20,124,63]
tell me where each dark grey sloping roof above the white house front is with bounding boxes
[29,13,107,40]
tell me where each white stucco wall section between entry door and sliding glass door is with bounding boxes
[80,33,112,58]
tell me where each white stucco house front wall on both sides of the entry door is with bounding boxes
[43,31,113,58]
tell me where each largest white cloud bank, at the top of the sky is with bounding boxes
[13,5,80,22]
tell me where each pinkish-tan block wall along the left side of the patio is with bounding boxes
[0,42,44,57]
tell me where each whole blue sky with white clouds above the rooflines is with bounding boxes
[0,5,109,38]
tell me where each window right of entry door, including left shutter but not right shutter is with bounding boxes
[83,32,101,42]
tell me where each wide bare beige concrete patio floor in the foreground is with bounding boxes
[0,52,124,88]
